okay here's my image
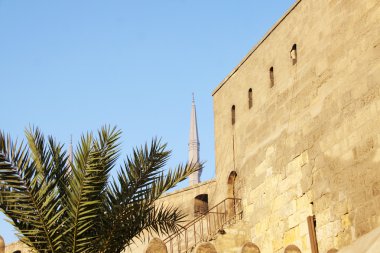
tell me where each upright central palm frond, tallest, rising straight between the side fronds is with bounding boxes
[65,127,121,253]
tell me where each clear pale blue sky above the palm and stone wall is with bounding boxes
[0,0,295,244]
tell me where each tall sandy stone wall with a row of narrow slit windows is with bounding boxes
[213,0,380,253]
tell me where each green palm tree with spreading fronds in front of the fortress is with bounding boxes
[0,126,199,253]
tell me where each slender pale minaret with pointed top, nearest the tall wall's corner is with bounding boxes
[189,93,202,185]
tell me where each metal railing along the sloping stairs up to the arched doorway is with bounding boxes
[164,198,243,253]
